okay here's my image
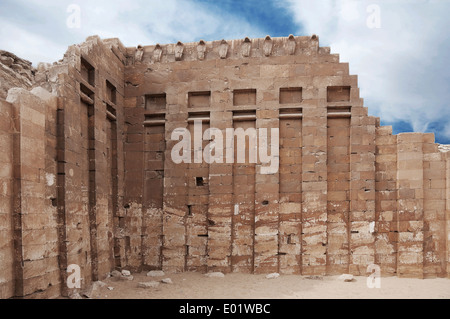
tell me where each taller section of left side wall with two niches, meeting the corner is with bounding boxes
[44,37,124,294]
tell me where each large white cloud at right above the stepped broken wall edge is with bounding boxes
[286,0,450,142]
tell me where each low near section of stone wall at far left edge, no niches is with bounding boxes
[2,88,60,297]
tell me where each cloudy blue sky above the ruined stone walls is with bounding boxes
[0,0,450,144]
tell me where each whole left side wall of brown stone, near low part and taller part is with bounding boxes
[1,37,126,298]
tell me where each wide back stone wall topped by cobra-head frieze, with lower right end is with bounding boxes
[124,36,448,278]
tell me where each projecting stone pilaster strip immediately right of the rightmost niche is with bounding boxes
[346,86,379,276]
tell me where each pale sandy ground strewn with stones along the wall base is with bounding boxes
[85,273,450,299]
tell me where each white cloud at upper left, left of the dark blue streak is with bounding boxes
[0,0,264,64]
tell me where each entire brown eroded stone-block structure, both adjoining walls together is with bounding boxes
[0,36,450,298]
